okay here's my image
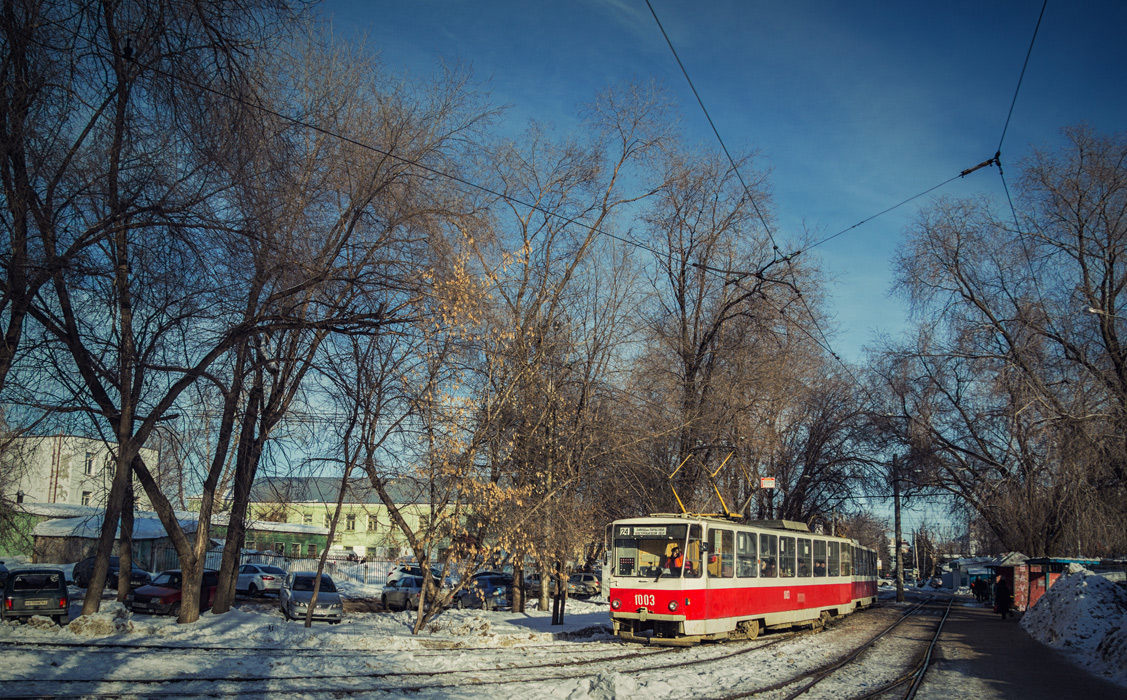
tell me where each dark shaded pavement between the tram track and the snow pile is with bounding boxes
[916,602,1127,700]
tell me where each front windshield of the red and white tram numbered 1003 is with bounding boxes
[614,523,701,578]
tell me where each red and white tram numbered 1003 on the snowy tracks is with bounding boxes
[607,515,877,645]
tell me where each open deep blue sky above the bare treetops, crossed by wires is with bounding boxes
[320,0,1127,362]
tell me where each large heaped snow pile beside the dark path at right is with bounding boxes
[1021,564,1127,684]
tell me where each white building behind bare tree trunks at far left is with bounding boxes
[0,435,158,510]
